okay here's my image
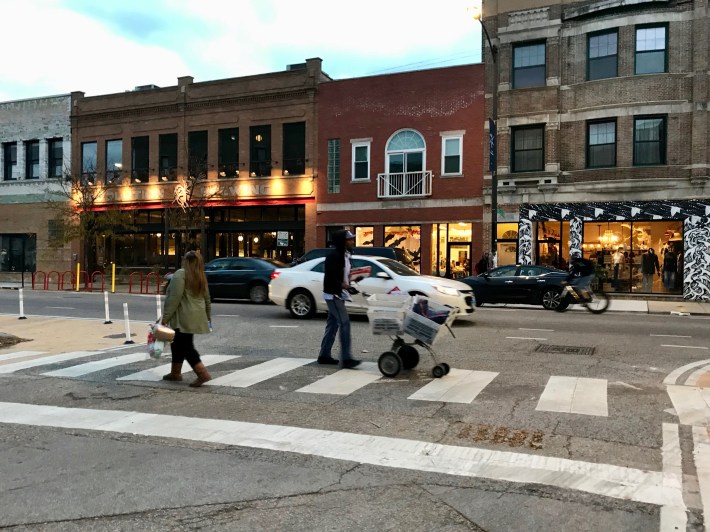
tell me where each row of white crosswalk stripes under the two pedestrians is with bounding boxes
[0,351,609,417]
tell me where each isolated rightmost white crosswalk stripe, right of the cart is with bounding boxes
[536,376,609,417]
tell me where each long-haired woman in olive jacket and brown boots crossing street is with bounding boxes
[161,251,212,388]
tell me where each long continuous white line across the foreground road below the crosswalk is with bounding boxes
[0,402,683,507]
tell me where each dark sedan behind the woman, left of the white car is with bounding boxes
[163,257,287,303]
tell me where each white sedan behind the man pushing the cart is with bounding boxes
[269,256,475,318]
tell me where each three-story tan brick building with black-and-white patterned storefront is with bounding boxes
[483,0,710,299]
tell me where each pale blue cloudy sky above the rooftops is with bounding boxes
[0,0,481,101]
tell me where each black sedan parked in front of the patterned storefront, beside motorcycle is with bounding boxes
[459,265,567,310]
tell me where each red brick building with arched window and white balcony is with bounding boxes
[316,64,484,277]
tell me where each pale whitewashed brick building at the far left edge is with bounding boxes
[0,94,72,282]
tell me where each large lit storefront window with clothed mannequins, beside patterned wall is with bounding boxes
[582,220,683,294]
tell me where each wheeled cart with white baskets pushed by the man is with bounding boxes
[363,294,459,379]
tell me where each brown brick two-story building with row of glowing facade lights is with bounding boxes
[71,59,329,271]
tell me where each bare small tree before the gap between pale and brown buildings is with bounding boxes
[45,168,132,273]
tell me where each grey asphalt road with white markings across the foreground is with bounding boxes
[0,291,710,531]
